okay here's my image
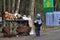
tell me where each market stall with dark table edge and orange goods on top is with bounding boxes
[2,13,31,36]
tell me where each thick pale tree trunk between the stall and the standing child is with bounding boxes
[29,0,35,34]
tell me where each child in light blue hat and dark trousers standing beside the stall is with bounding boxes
[34,13,42,37]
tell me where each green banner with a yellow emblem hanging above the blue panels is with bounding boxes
[43,0,54,12]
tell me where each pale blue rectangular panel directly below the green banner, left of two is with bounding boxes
[46,12,54,26]
